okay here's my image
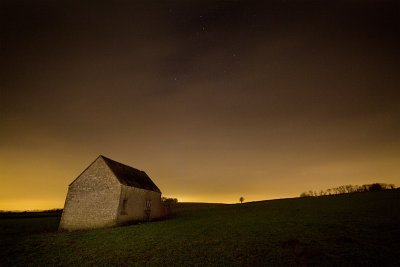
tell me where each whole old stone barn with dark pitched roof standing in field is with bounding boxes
[59,155,164,230]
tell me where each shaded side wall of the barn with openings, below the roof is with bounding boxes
[118,185,165,224]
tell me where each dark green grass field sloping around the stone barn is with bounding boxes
[0,190,400,266]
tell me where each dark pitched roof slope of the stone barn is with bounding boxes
[100,155,161,193]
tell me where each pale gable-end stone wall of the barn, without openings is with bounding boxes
[60,157,121,230]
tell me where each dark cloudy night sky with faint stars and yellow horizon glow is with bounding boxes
[0,0,400,210]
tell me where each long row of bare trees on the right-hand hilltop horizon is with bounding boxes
[300,183,396,197]
